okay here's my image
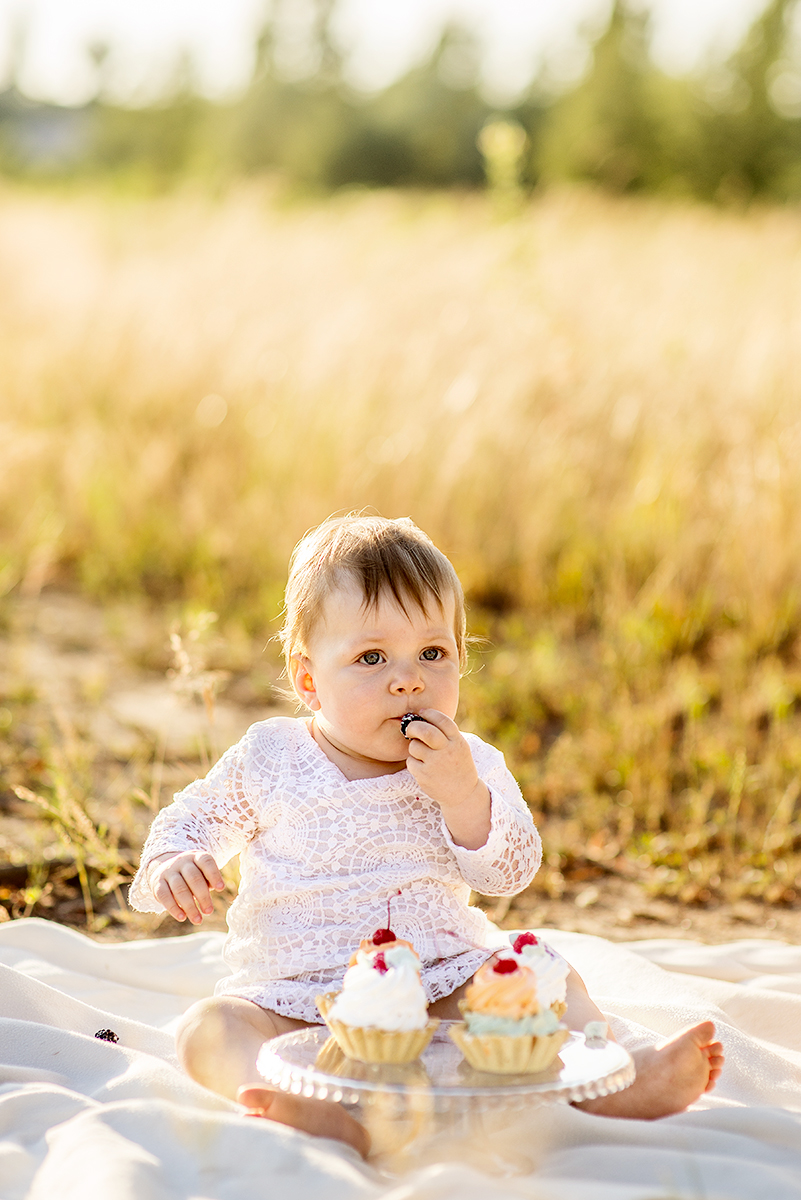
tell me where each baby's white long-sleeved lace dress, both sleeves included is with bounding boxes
[130,716,541,1022]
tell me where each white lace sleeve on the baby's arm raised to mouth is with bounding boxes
[442,734,542,896]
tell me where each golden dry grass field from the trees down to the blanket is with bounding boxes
[0,186,801,930]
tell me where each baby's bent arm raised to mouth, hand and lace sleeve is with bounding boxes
[406,709,542,895]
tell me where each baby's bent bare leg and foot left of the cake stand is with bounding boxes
[175,996,369,1156]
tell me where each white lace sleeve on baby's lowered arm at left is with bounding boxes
[128,726,259,912]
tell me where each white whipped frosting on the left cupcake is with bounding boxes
[329,944,428,1032]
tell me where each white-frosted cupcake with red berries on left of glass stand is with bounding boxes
[317,929,439,1063]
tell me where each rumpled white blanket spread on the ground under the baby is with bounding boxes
[0,919,801,1200]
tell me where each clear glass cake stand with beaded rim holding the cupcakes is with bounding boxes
[258,1021,634,1174]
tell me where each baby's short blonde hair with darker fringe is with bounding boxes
[279,514,466,667]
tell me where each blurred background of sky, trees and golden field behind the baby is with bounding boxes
[0,0,801,936]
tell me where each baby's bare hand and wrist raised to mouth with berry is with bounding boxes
[406,708,490,850]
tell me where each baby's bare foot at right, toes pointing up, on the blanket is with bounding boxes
[576,1021,723,1121]
